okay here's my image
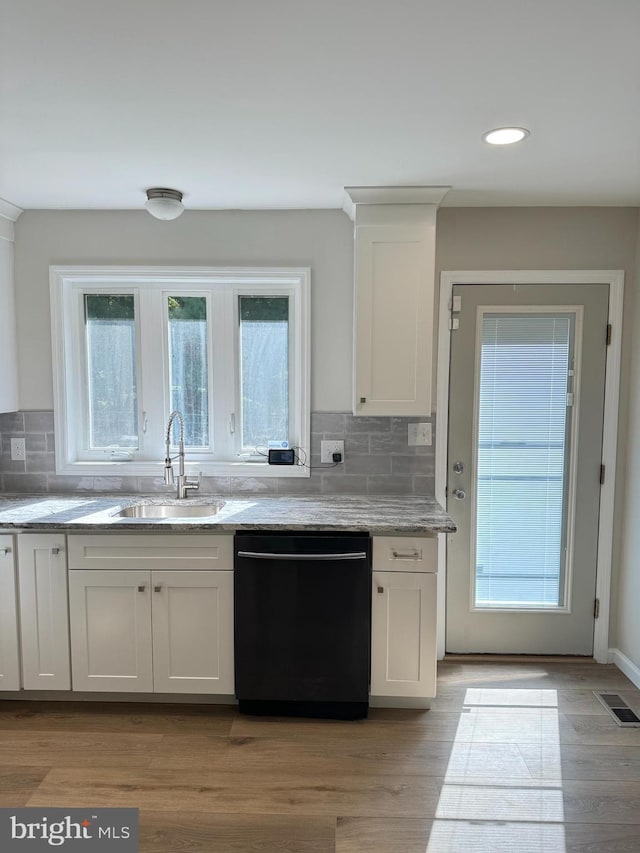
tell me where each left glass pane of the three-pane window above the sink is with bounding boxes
[84,293,138,450]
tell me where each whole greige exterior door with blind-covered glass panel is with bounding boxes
[446,285,608,655]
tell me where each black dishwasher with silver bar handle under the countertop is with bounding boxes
[234,532,371,719]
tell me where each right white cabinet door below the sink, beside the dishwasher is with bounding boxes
[152,571,234,694]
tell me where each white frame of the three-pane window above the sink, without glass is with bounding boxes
[49,266,311,477]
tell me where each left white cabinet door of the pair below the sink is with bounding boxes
[69,570,153,693]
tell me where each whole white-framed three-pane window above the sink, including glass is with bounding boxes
[51,267,309,477]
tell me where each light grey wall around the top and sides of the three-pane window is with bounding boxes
[15,210,353,412]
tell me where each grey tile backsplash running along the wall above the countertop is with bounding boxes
[0,411,435,495]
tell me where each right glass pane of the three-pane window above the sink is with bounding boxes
[238,296,290,451]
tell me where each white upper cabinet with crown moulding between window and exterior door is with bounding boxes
[345,187,446,416]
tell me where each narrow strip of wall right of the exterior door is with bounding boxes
[613,215,640,668]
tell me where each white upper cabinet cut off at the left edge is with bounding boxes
[0,199,22,412]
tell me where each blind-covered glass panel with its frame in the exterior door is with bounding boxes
[471,306,581,610]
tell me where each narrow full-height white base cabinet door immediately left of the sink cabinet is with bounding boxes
[18,533,71,690]
